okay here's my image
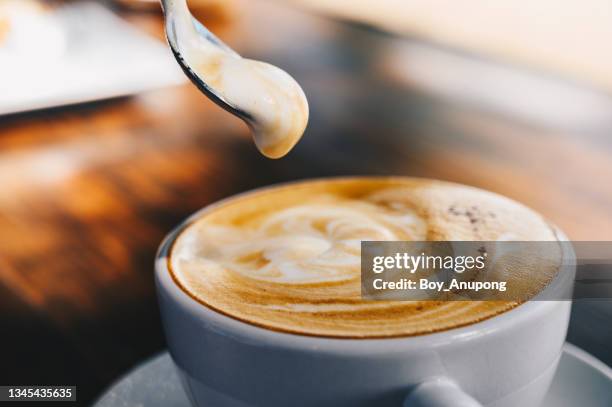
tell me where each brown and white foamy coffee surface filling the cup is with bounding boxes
[169,178,556,338]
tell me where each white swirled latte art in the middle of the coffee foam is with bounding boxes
[186,202,424,284]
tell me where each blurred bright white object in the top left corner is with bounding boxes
[0,0,185,114]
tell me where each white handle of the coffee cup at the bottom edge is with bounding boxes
[403,377,482,407]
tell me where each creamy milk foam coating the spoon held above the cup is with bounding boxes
[175,0,308,158]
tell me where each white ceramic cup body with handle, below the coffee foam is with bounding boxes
[155,193,574,407]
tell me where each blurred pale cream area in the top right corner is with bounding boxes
[293,0,612,92]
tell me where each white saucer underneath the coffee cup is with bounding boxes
[94,343,612,407]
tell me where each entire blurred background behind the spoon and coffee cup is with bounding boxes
[0,0,612,405]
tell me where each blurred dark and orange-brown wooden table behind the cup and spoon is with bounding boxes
[0,2,612,404]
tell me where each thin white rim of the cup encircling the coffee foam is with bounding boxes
[155,176,574,355]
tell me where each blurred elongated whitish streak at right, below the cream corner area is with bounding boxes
[376,39,612,132]
